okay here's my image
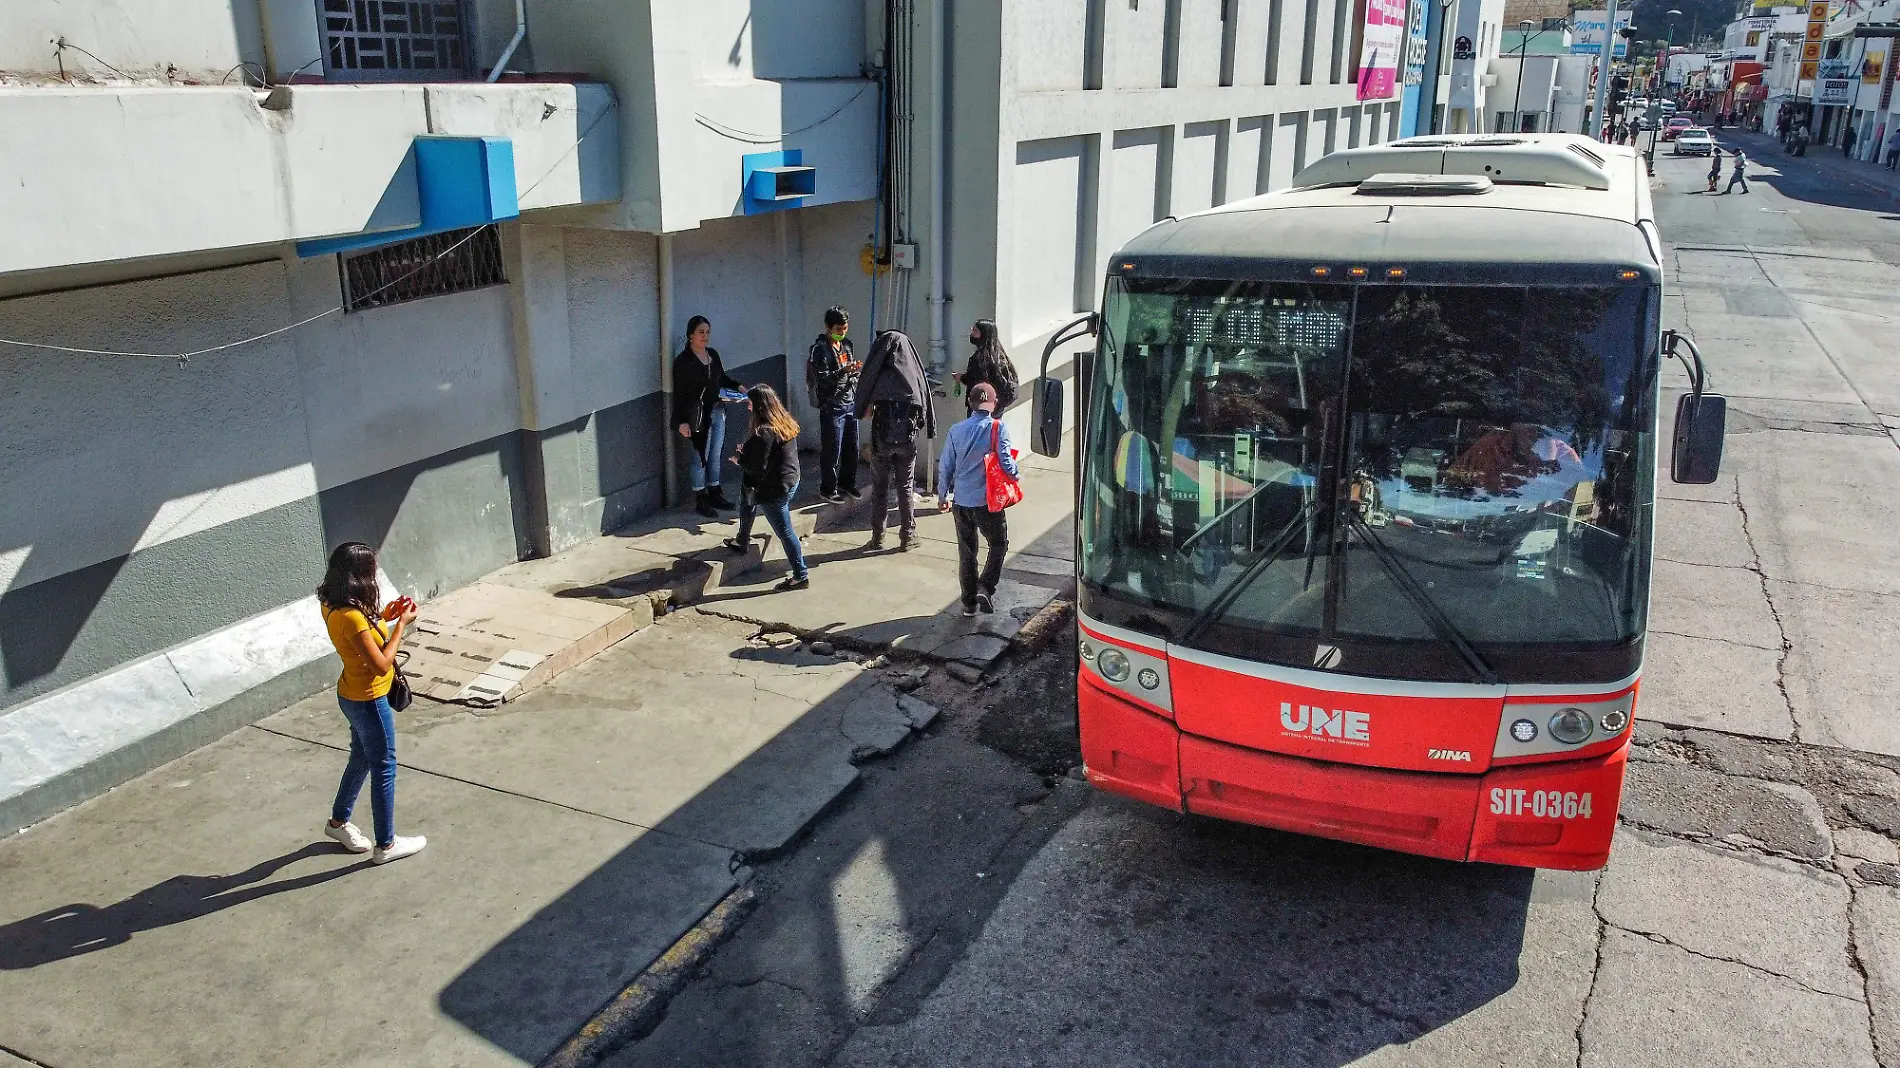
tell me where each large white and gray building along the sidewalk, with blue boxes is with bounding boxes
[0,0,1503,827]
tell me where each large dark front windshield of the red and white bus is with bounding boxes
[1081,269,1657,682]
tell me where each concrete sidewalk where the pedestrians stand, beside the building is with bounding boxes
[0,452,1072,1068]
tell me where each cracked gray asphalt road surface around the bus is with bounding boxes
[606,139,1900,1068]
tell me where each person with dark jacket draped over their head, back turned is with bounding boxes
[857,331,937,553]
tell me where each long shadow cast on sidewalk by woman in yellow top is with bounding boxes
[0,842,369,971]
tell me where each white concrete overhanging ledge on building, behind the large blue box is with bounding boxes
[0,84,619,274]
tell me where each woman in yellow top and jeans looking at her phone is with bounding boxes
[317,542,428,865]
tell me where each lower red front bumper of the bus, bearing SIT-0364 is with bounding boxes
[1077,677,1628,870]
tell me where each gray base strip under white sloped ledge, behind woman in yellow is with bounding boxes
[0,654,342,834]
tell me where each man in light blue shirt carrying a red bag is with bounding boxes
[937,382,1018,616]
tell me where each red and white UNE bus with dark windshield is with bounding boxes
[1034,135,1723,870]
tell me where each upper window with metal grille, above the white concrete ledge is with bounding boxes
[317,0,469,82]
